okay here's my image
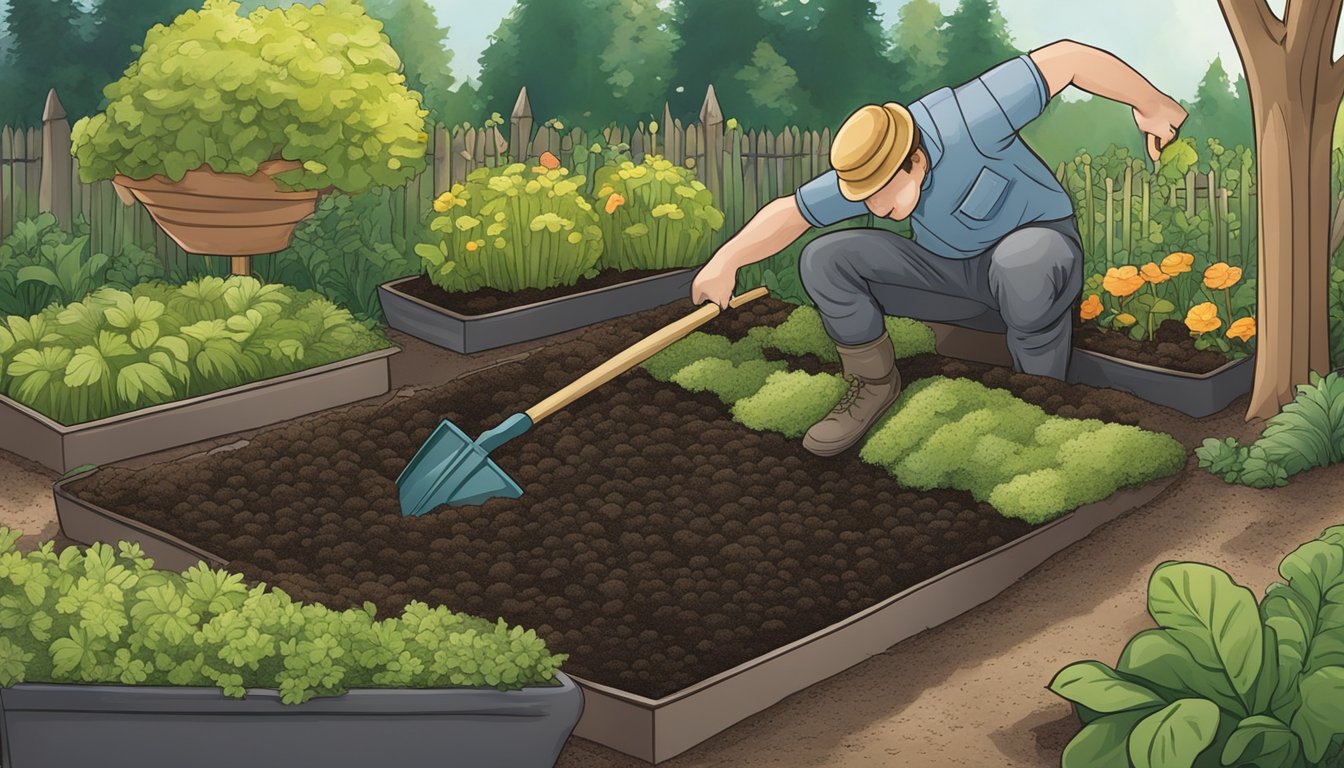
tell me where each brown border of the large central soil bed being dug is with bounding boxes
[55,469,1179,764]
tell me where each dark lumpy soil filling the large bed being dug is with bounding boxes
[73,301,1148,698]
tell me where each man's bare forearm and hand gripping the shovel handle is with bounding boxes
[691,195,810,307]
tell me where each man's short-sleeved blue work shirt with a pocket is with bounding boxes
[796,55,1074,258]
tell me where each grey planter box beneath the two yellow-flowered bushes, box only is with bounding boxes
[378,268,699,354]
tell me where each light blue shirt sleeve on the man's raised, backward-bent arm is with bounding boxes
[956,54,1050,149]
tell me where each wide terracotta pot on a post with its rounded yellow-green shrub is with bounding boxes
[71,0,427,273]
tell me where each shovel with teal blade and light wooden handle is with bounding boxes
[396,288,769,516]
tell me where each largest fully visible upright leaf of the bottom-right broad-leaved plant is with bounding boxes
[1148,562,1263,716]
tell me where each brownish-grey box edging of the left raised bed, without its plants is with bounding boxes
[0,347,401,472]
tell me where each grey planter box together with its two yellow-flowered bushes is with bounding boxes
[379,149,723,352]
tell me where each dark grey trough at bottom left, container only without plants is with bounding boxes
[0,674,583,768]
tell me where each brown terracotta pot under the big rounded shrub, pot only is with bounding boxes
[112,160,317,256]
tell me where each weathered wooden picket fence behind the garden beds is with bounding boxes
[0,86,1254,272]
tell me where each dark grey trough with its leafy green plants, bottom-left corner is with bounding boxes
[0,527,583,768]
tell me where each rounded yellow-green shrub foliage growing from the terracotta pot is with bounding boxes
[71,0,429,194]
